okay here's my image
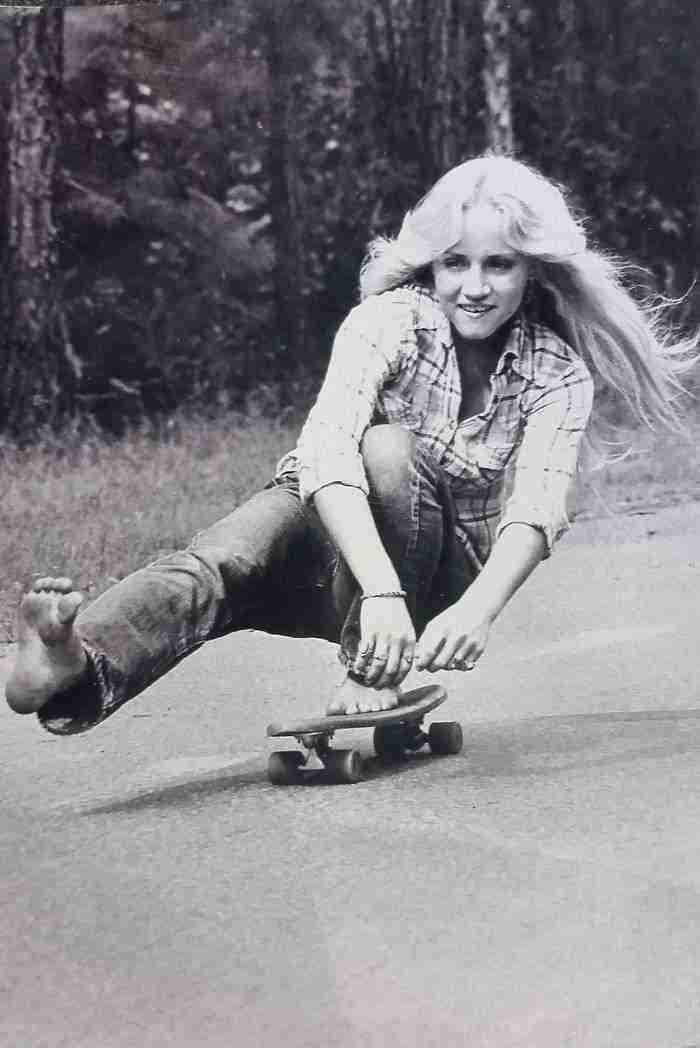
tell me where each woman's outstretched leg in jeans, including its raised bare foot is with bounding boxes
[6,486,335,734]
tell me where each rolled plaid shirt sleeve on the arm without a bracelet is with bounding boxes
[497,358,593,556]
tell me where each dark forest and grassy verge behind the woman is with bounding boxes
[0,0,700,639]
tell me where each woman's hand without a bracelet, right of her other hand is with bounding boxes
[414,598,493,673]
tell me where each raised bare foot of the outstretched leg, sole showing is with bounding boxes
[5,578,87,714]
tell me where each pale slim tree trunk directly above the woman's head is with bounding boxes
[482,0,513,153]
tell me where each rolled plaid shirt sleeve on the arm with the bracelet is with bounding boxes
[296,292,416,500]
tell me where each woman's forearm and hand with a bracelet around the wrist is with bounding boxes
[313,484,416,686]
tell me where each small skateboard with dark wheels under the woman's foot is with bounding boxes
[267,684,462,786]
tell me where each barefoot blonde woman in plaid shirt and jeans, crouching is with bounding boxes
[6,157,696,733]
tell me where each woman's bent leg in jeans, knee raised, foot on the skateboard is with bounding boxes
[332,424,474,712]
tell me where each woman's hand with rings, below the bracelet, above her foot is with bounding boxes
[352,597,416,687]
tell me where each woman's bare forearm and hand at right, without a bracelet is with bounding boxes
[416,523,546,673]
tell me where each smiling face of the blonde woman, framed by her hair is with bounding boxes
[433,204,528,341]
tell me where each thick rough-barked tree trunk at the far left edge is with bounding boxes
[0,7,63,433]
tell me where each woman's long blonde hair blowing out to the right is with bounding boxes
[360,156,700,440]
